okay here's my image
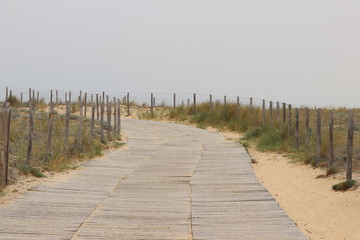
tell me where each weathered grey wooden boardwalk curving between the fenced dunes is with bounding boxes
[0,120,305,240]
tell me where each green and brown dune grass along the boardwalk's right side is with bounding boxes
[143,102,360,188]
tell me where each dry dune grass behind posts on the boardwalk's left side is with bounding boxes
[3,101,123,182]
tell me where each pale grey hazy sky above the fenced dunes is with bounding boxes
[0,0,360,106]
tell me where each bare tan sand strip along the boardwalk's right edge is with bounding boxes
[208,128,360,240]
